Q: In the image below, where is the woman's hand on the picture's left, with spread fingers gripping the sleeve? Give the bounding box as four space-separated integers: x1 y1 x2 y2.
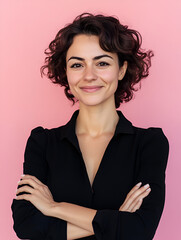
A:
16 175 56 216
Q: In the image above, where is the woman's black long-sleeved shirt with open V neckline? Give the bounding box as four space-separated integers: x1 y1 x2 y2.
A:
12 110 169 240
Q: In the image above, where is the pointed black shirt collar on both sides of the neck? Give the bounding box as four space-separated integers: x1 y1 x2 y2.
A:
60 110 134 140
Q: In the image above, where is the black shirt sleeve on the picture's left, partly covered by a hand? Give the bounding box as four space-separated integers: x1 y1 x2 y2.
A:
11 127 67 240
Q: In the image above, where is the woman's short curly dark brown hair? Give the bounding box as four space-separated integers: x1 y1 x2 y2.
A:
41 13 154 108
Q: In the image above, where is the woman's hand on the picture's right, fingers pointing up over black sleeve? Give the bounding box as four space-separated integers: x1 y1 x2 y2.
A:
119 182 151 213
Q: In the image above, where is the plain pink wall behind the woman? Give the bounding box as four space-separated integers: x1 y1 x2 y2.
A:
0 0 181 240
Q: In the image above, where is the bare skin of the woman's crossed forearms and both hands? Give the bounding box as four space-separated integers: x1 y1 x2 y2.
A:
16 175 151 240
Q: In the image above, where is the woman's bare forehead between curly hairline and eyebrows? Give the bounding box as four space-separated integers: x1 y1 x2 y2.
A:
66 34 117 59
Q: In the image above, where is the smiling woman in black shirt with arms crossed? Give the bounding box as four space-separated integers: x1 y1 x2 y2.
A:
12 13 169 240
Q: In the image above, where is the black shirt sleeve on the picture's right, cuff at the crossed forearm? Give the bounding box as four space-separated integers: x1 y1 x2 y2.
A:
92 128 169 240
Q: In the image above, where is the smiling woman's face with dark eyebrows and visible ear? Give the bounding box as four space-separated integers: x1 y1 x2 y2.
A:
66 34 127 106
